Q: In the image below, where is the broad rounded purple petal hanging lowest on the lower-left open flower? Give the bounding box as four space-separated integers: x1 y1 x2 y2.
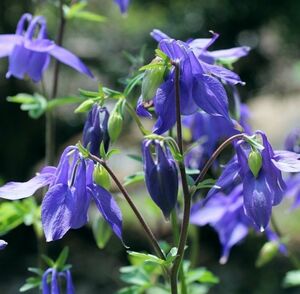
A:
42 184 74 242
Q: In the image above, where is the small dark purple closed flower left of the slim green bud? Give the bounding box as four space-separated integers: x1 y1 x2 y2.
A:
83 104 109 157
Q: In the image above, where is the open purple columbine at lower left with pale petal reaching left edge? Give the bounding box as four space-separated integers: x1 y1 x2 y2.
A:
0 146 122 241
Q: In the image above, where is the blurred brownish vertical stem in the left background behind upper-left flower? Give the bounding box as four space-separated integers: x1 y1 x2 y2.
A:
45 0 66 165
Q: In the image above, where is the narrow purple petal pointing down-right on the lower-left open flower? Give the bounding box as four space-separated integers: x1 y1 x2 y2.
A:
90 185 122 240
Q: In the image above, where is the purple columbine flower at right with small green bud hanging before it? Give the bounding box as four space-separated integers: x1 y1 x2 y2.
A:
207 131 300 231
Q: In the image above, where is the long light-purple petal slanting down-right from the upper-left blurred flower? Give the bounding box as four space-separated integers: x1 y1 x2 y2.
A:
49 45 94 78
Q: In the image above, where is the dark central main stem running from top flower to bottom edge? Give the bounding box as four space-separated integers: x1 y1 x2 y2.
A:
171 63 191 294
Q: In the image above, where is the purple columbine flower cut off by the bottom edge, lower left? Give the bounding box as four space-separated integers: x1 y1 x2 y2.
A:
42 268 75 294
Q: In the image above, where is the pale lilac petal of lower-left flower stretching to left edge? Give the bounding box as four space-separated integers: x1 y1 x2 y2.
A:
0 167 54 200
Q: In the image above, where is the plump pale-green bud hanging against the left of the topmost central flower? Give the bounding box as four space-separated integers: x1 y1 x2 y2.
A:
142 59 166 102
